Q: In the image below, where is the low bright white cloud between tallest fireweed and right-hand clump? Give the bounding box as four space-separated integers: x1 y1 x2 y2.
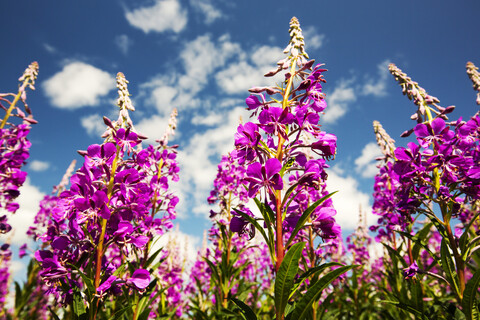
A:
327 168 376 230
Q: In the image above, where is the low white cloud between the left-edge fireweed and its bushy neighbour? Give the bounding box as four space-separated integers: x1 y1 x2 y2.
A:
1 178 44 245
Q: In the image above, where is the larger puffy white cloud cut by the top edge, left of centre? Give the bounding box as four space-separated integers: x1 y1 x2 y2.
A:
125 0 188 33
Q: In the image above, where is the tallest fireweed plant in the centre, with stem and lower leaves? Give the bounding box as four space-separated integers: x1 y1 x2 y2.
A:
223 17 352 320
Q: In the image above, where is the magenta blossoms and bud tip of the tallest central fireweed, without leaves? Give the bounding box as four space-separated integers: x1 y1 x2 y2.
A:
232 18 339 269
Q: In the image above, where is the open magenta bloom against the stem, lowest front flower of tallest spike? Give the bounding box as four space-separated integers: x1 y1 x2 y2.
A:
246 158 283 198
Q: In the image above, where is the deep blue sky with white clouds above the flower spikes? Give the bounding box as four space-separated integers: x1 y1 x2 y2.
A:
0 0 480 262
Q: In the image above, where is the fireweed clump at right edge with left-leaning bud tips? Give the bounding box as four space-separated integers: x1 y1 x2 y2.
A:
371 62 480 319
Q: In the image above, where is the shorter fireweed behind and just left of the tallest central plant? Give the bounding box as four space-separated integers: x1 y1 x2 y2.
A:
187 155 274 319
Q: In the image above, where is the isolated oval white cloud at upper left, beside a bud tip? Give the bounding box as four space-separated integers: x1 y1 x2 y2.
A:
43 61 115 109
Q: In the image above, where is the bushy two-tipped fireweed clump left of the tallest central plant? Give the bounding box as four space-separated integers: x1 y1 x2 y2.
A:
31 73 179 319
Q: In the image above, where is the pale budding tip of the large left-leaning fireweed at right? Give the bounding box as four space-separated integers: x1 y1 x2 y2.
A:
388 63 455 131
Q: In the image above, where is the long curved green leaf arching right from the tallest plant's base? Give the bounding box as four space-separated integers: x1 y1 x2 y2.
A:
291 266 356 320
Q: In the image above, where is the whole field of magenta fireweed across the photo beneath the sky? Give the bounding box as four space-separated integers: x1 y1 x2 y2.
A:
0 18 480 320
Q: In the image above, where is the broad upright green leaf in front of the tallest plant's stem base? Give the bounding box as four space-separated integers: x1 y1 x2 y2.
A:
275 242 305 314
